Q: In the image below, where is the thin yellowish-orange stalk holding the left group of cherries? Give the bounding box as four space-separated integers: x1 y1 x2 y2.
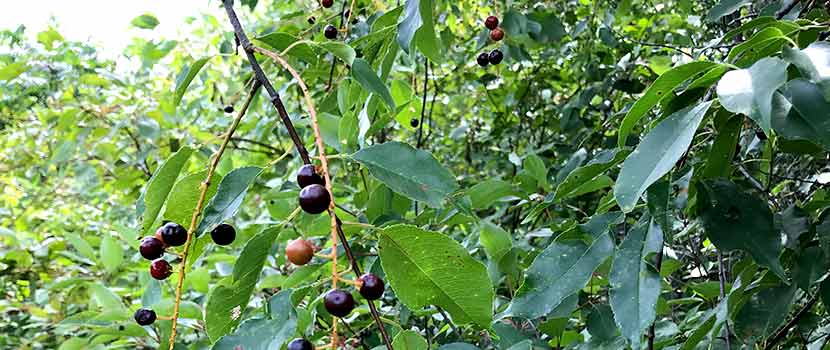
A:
169 81 262 350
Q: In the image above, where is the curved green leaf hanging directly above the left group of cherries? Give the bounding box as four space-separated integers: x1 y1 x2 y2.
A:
138 147 193 235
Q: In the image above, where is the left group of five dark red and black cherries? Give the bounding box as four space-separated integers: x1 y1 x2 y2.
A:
133 222 236 326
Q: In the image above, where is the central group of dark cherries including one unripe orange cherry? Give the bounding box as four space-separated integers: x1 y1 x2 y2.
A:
285 164 385 350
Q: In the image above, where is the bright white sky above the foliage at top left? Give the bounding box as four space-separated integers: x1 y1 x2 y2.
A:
0 0 221 58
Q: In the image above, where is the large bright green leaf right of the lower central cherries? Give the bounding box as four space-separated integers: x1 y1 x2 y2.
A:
378 225 494 328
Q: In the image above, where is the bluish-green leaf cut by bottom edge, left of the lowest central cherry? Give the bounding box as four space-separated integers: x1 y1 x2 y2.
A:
211 318 297 350
